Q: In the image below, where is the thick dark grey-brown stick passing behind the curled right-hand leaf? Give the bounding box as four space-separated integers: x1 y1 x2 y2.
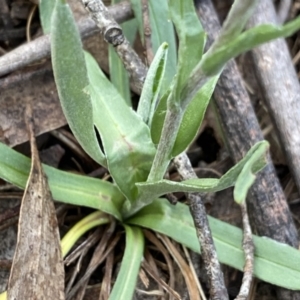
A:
196 0 299 300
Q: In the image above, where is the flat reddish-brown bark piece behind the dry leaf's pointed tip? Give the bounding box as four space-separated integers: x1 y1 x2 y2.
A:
0 64 66 146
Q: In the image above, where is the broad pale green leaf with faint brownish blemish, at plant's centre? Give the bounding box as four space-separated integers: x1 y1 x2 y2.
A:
85 54 155 201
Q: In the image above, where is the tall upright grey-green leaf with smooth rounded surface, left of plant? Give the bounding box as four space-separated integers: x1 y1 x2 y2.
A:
51 0 106 166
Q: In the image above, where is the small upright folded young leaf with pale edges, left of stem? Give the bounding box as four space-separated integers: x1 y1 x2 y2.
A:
137 43 168 126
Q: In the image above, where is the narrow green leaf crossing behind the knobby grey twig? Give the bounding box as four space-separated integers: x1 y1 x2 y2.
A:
108 0 137 106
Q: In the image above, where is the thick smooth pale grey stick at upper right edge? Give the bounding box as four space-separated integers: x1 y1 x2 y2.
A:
248 0 300 197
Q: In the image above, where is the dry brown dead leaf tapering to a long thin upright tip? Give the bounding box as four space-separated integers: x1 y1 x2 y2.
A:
7 105 65 300
